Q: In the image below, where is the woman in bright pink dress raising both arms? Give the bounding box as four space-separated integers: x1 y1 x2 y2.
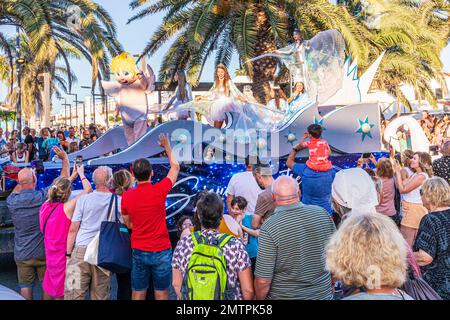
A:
39 166 92 300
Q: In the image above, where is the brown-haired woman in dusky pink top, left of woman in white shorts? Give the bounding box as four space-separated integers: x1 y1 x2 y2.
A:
376 158 400 226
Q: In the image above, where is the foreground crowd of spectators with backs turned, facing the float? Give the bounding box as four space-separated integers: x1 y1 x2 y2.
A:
2 121 450 300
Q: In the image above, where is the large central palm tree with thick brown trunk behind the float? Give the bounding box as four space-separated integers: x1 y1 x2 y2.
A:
128 0 369 102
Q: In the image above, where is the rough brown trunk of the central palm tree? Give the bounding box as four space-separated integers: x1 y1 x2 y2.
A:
252 10 277 104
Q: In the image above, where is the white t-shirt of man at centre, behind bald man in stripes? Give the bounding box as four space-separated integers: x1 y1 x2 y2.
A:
226 171 264 214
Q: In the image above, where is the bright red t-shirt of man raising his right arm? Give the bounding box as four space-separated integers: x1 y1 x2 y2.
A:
121 178 172 252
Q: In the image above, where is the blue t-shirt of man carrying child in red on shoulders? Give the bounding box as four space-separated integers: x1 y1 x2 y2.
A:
292 163 336 215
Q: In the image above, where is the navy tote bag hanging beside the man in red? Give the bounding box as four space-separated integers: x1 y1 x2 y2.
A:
97 194 132 273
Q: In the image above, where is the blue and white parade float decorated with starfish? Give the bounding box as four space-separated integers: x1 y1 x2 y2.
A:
3 30 383 240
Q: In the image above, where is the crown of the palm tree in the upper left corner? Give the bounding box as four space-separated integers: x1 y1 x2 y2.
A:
0 0 122 119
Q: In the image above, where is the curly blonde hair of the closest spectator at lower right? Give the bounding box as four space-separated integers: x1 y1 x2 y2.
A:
326 214 407 289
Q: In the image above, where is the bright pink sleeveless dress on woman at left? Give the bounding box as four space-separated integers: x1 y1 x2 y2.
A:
39 201 70 297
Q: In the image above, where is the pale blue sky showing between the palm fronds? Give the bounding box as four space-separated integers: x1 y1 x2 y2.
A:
0 0 450 110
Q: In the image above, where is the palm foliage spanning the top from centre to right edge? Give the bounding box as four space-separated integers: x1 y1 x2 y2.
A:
129 0 450 105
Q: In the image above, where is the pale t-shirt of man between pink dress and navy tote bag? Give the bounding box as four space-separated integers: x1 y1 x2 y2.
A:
72 191 121 247
